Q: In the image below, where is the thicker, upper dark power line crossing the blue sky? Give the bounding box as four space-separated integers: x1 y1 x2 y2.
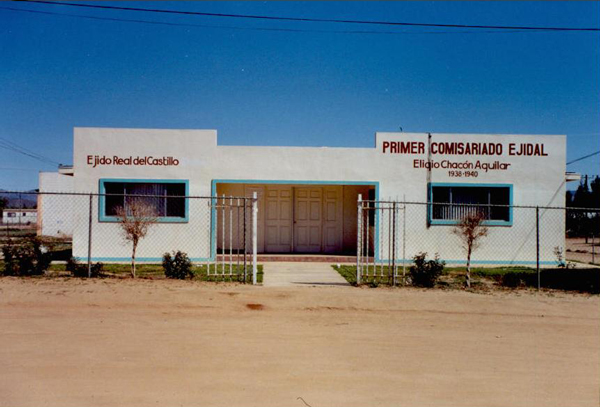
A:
12 0 600 31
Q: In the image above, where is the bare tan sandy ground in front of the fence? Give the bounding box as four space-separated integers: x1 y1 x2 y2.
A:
0 278 600 407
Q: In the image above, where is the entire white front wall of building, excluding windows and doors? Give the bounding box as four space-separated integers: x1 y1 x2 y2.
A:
67 128 566 262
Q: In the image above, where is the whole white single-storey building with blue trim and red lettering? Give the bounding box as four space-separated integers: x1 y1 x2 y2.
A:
40 128 566 264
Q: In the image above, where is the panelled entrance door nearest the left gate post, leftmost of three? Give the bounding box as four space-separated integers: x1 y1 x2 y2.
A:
265 186 293 253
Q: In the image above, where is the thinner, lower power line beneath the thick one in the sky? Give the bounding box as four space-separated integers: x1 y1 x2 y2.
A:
0 6 542 35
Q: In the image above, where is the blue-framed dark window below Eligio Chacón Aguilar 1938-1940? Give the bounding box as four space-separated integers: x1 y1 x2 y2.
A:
429 184 512 225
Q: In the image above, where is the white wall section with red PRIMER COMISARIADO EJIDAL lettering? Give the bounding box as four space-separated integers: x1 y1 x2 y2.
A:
376 133 566 264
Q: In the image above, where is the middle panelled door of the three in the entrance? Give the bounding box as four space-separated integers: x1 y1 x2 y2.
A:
294 187 323 253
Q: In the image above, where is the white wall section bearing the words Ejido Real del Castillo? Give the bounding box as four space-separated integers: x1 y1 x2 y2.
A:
73 128 217 261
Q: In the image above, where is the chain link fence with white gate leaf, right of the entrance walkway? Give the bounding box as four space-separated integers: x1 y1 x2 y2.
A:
356 198 600 286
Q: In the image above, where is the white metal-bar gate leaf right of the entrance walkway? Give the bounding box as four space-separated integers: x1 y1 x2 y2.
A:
356 195 406 285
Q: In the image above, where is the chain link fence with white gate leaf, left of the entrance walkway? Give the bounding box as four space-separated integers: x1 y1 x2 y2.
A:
0 192 258 283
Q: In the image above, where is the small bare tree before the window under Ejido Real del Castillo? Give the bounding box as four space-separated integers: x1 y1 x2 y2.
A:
117 199 157 278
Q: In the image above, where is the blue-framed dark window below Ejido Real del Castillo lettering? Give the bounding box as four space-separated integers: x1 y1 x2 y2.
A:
98 178 189 223
